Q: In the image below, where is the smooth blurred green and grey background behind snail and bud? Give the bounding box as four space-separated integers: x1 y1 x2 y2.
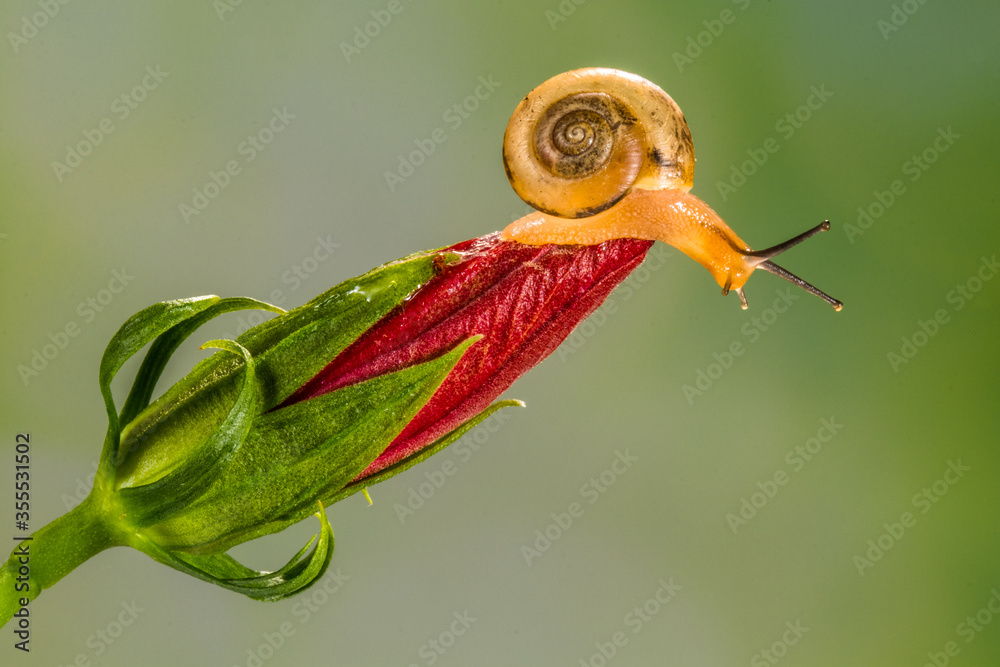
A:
0 0 1000 667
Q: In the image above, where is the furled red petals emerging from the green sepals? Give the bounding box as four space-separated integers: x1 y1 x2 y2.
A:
285 233 652 479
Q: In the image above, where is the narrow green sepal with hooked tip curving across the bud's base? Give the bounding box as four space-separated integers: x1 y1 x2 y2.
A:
118 342 257 528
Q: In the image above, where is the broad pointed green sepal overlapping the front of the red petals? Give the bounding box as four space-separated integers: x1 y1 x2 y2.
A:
144 336 480 553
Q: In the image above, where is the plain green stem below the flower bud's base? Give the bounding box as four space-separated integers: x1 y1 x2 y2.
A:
0 496 122 626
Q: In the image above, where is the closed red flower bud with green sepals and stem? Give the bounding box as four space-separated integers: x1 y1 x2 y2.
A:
0 234 650 618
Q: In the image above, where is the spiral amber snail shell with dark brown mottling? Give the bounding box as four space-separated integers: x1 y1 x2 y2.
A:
503 68 694 218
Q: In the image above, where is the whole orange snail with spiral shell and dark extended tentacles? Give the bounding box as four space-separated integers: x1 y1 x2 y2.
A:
501 68 843 310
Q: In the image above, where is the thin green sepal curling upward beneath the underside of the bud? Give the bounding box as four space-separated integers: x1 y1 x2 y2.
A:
132 504 334 602
